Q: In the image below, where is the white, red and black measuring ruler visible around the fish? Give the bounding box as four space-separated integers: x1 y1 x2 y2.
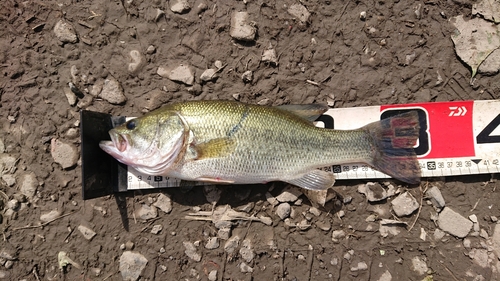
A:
81 100 500 199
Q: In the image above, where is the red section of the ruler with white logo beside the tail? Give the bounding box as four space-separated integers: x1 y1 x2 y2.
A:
380 101 475 159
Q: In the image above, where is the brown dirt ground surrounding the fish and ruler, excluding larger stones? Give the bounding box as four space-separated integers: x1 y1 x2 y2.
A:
0 0 500 280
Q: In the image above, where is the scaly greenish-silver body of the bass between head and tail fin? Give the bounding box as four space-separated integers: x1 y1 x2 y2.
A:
168 102 370 183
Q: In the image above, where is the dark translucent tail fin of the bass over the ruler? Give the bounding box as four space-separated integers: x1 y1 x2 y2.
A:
363 111 421 184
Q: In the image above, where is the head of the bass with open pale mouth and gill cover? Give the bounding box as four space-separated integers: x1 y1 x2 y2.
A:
99 111 189 175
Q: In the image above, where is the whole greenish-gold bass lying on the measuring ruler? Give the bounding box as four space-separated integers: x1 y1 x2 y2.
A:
99 101 421 190
